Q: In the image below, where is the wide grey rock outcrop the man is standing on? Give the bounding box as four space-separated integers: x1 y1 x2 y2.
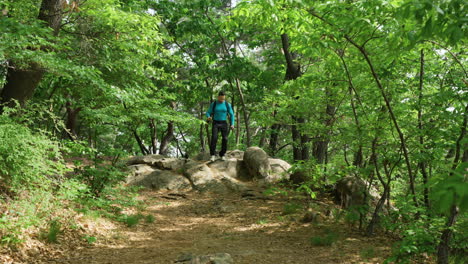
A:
127 147 291 193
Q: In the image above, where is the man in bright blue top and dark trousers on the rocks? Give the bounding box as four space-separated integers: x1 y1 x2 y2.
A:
206 92 234 161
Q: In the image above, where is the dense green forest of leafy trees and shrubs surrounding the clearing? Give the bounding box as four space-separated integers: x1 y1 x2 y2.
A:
0 0 468 263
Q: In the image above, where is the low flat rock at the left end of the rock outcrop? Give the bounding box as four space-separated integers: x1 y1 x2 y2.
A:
127 169 192 190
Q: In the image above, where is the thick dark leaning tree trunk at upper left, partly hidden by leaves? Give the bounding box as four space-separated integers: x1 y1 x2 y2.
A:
0 0 63 113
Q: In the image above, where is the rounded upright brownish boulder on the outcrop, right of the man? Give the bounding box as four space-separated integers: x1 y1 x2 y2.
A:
244 147 271 179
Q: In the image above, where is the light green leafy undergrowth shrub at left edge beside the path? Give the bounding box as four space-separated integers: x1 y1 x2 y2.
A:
0 113 142 247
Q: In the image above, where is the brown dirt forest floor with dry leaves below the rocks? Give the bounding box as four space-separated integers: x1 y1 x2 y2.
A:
1 185 404 264
